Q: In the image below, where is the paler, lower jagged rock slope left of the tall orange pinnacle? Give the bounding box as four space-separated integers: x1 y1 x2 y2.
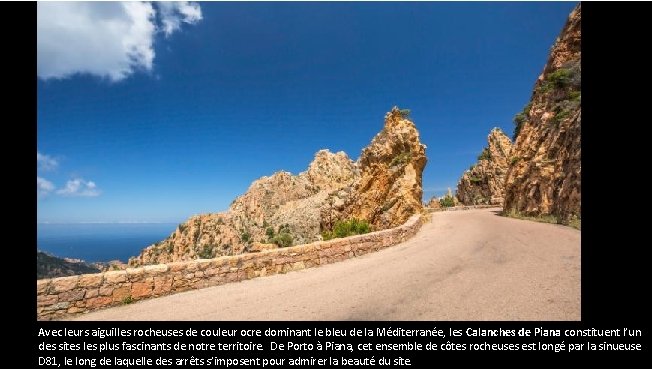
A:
129 150 355 266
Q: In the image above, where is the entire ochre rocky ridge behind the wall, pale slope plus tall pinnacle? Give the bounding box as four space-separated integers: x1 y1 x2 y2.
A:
129 108 426 266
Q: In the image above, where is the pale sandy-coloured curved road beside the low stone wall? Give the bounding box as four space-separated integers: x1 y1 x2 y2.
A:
72 209 580 320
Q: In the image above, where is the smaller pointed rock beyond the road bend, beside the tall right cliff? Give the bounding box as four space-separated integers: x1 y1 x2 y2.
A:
457 128 512 205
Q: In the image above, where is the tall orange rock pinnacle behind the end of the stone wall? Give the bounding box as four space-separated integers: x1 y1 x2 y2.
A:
345 107 426 229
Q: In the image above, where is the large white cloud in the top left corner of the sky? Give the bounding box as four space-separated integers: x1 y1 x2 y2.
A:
36 1 201 81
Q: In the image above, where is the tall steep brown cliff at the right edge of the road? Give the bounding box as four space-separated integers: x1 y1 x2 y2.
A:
504 5 582 223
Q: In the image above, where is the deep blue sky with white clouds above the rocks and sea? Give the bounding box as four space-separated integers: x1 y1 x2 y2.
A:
37 2 575 222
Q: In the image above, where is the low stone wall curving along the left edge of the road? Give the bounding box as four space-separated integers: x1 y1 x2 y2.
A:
36 215 422 320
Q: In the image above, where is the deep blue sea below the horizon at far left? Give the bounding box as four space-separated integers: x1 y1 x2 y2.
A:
36 223 177 263
